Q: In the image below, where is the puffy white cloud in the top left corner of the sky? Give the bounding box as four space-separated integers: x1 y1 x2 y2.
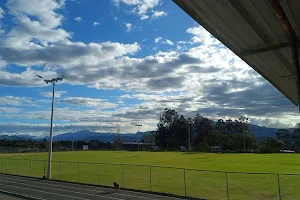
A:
0 0 71 49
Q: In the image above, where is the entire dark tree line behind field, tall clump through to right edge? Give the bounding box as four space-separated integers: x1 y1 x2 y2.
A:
152 109 300 153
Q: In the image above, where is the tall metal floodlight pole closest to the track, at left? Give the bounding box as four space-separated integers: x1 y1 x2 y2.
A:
37 75 67 179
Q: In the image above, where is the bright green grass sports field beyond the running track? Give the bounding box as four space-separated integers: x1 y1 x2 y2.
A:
0 151 300 200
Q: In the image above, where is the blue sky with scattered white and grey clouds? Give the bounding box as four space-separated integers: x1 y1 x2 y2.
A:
0 0 300 136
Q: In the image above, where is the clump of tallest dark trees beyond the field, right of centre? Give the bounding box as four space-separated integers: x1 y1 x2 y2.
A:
153 109 257 152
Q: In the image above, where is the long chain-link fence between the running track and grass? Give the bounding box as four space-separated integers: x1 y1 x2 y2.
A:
0 158 300 200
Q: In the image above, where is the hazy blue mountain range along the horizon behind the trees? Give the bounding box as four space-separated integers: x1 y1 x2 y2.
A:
0 124 293 142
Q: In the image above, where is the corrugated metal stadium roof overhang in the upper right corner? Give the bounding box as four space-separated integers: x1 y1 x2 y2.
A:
173 0 300 105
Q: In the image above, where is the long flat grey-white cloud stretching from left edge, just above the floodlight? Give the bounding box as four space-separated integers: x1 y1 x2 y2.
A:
0 42 140 67
